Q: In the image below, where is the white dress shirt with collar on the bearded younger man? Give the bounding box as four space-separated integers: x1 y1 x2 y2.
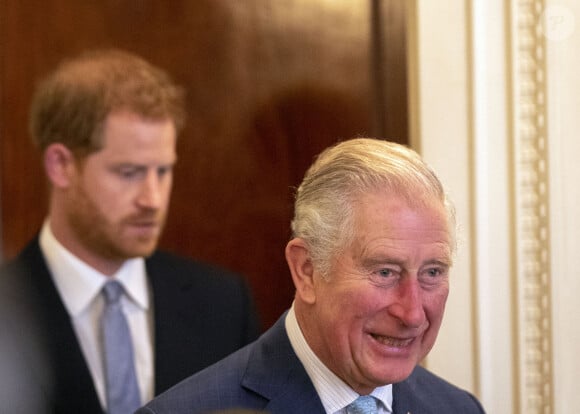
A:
40 220 155 409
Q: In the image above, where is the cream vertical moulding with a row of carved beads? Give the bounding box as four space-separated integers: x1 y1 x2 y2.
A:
512 0 554 414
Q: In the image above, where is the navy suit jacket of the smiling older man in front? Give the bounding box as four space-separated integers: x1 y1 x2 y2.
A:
136 315 484 414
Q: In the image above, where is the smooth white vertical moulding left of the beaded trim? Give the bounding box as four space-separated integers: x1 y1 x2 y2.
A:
468 0 518 414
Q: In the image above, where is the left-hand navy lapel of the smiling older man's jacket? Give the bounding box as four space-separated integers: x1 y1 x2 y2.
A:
237 313 325 414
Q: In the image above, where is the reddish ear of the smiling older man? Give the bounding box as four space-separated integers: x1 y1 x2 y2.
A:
285 238 316 304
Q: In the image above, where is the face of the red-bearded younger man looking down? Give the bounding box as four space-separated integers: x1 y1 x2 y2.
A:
68 111 176 268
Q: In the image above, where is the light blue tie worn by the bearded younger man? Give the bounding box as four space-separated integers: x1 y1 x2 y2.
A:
101 281 141 414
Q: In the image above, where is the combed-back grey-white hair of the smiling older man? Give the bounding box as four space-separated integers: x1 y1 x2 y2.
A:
291 138 456 277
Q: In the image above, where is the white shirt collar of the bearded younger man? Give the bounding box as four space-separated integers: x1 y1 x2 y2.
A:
39 220 149 317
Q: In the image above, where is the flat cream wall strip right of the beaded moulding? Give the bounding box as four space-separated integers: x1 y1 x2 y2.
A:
547 0 580 414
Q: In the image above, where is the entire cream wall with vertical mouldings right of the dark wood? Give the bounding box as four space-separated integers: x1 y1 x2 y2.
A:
408 0 580 414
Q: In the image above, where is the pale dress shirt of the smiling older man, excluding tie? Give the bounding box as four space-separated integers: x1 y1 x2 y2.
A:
285 304 393 414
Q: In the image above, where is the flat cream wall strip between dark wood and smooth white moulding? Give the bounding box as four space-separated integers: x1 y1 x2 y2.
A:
409 1 476 396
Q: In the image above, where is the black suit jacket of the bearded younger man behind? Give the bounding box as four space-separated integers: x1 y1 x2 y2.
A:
0 239 259 414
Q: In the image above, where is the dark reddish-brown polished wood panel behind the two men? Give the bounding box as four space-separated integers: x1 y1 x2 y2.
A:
0 0 407 327
